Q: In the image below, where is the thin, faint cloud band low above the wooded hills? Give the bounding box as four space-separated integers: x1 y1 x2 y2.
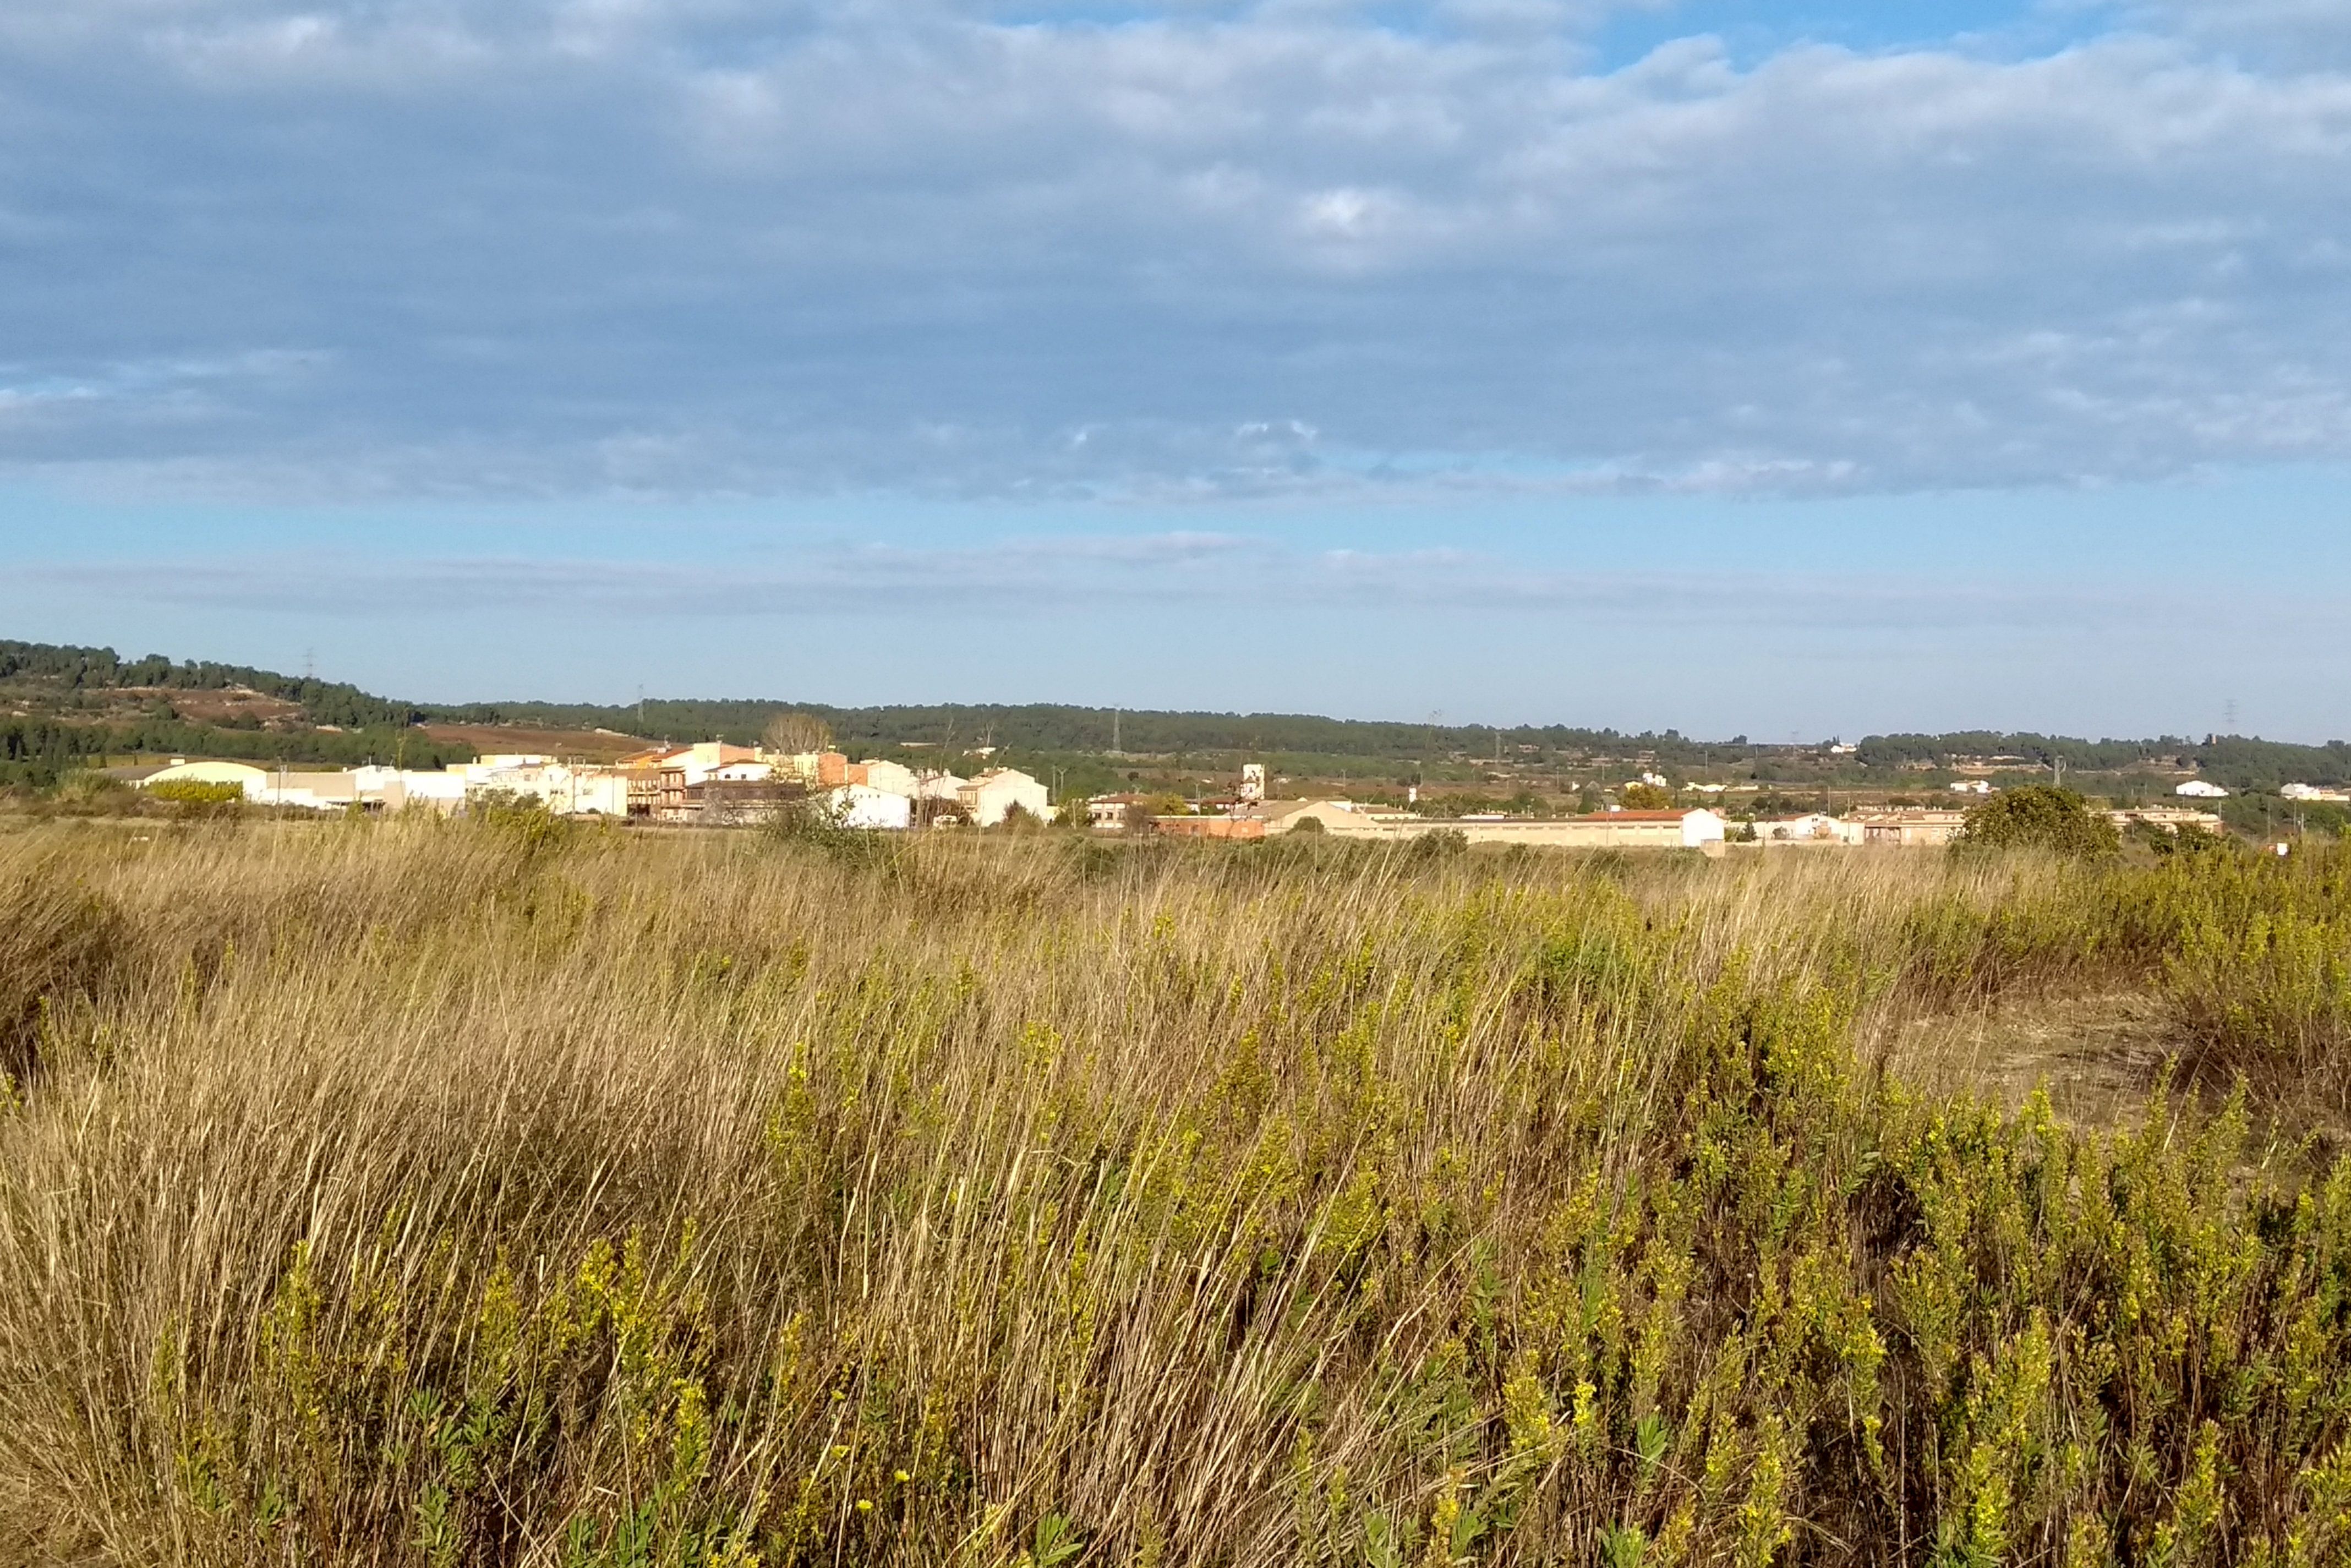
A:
19 531 2346 637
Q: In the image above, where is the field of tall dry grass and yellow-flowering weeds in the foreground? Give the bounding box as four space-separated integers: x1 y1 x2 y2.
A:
0 816 2351 1568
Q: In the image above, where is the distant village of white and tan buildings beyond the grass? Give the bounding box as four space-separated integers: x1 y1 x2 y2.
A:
127 740 2248 856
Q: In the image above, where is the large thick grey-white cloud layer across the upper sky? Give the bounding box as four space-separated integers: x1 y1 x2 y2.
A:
0 0 2351 501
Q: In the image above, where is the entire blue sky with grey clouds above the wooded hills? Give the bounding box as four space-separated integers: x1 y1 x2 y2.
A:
0 0 2351 740
